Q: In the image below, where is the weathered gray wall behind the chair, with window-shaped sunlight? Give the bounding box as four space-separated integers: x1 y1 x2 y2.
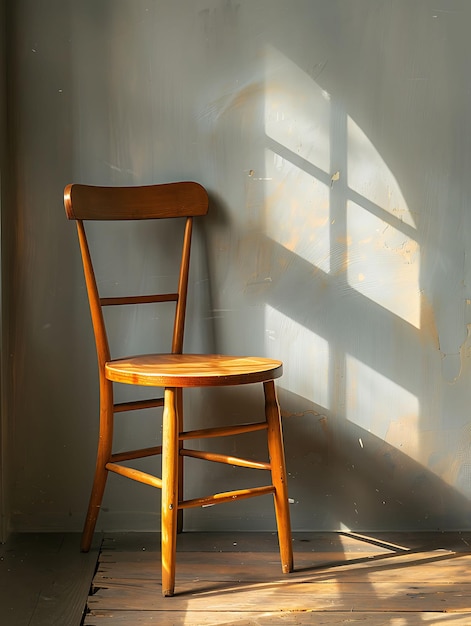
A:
5 0 471 530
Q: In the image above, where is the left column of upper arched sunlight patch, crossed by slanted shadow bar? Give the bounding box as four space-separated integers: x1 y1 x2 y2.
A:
265 48 330 272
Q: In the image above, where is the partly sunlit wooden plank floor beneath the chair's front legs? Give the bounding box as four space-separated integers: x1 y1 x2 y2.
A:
84 533 471 626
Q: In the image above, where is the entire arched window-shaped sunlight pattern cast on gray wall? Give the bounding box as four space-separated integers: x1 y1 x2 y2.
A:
264 47 420 450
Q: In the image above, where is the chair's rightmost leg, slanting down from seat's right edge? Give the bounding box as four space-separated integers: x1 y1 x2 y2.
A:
263 380 293 574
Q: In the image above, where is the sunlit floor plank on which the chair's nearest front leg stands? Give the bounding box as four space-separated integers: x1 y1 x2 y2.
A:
88 580 471 613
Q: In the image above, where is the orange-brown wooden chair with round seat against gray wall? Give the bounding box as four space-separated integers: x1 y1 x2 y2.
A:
64 182 293 596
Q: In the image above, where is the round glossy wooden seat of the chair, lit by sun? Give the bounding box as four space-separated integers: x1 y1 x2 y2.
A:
105 354 283 387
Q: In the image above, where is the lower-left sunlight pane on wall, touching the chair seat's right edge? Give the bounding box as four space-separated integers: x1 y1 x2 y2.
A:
265 305 329 408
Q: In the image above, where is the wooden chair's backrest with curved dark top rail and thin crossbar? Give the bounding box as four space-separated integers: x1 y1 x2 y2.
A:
64 182 208 372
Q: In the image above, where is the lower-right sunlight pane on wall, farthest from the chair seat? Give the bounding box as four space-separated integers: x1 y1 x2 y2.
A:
345 354 420 450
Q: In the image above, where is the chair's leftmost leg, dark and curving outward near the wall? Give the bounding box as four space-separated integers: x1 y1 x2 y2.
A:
80 380 114 552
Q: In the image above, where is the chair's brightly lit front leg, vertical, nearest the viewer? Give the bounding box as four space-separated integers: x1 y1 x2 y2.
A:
161 388 180 596
